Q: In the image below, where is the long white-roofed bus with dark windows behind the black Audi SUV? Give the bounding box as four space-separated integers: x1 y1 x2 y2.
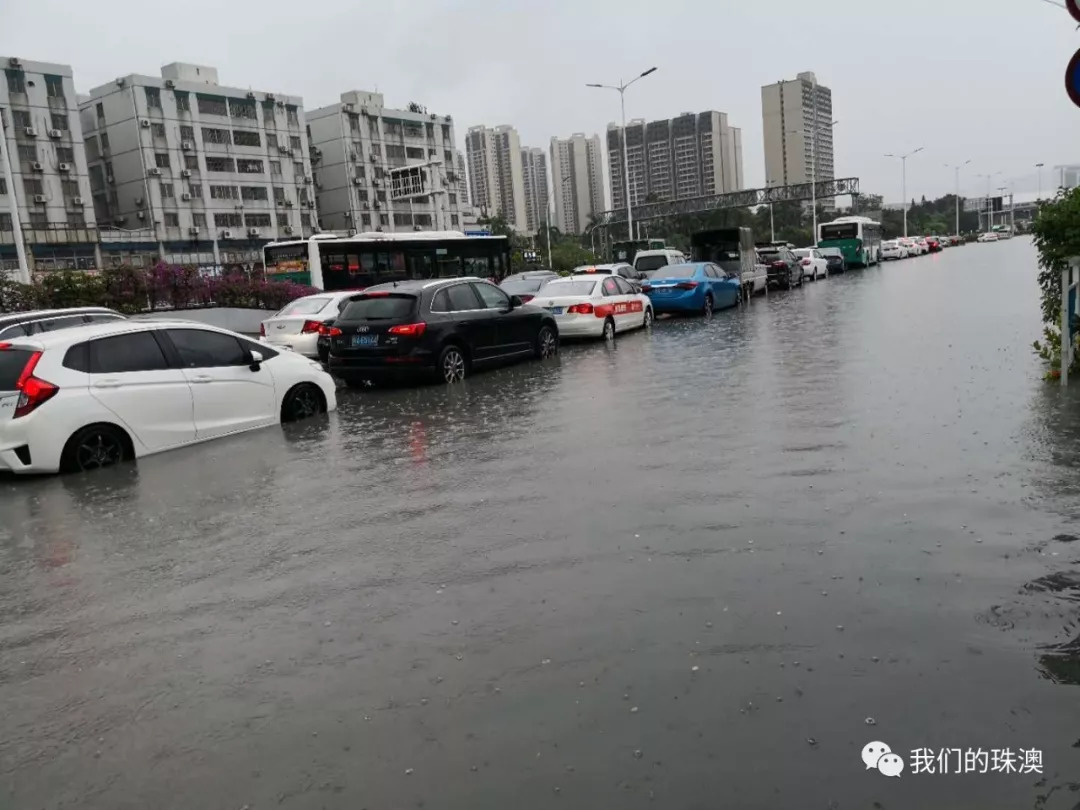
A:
262 231 510 291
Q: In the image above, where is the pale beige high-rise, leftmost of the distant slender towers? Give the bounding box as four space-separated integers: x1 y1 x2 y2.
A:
465 125 529 233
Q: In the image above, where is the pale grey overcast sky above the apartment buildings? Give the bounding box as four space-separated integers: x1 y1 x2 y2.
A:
0 0 1080 206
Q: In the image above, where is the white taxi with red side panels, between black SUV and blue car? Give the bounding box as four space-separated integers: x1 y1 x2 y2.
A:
529 274 652 340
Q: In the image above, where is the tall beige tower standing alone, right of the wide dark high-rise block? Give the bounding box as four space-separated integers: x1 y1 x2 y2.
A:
761 71 836 211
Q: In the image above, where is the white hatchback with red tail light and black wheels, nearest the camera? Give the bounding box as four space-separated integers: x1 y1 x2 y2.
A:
0 321 337 473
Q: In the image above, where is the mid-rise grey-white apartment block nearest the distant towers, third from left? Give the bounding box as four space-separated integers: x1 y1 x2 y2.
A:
308 90 464 232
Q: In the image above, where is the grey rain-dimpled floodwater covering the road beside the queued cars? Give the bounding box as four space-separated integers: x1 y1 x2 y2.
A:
0 239 1080 810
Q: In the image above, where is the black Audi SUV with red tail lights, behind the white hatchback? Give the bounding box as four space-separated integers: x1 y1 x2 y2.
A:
328 279 558 387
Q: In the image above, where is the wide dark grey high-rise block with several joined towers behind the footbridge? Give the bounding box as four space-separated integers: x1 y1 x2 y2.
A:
607 110 743 208
